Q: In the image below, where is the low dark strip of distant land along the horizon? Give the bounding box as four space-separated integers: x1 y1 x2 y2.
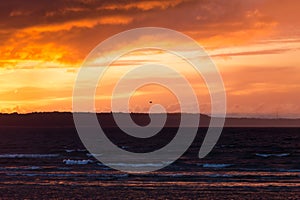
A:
0 112 300 127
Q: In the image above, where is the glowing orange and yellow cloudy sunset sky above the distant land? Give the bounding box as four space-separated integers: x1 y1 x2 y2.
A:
0 0 300 118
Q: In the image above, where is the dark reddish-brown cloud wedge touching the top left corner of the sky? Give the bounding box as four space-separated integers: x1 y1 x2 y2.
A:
0 0 188 29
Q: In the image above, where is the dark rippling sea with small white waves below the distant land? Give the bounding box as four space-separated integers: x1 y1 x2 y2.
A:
0 127 300 199
